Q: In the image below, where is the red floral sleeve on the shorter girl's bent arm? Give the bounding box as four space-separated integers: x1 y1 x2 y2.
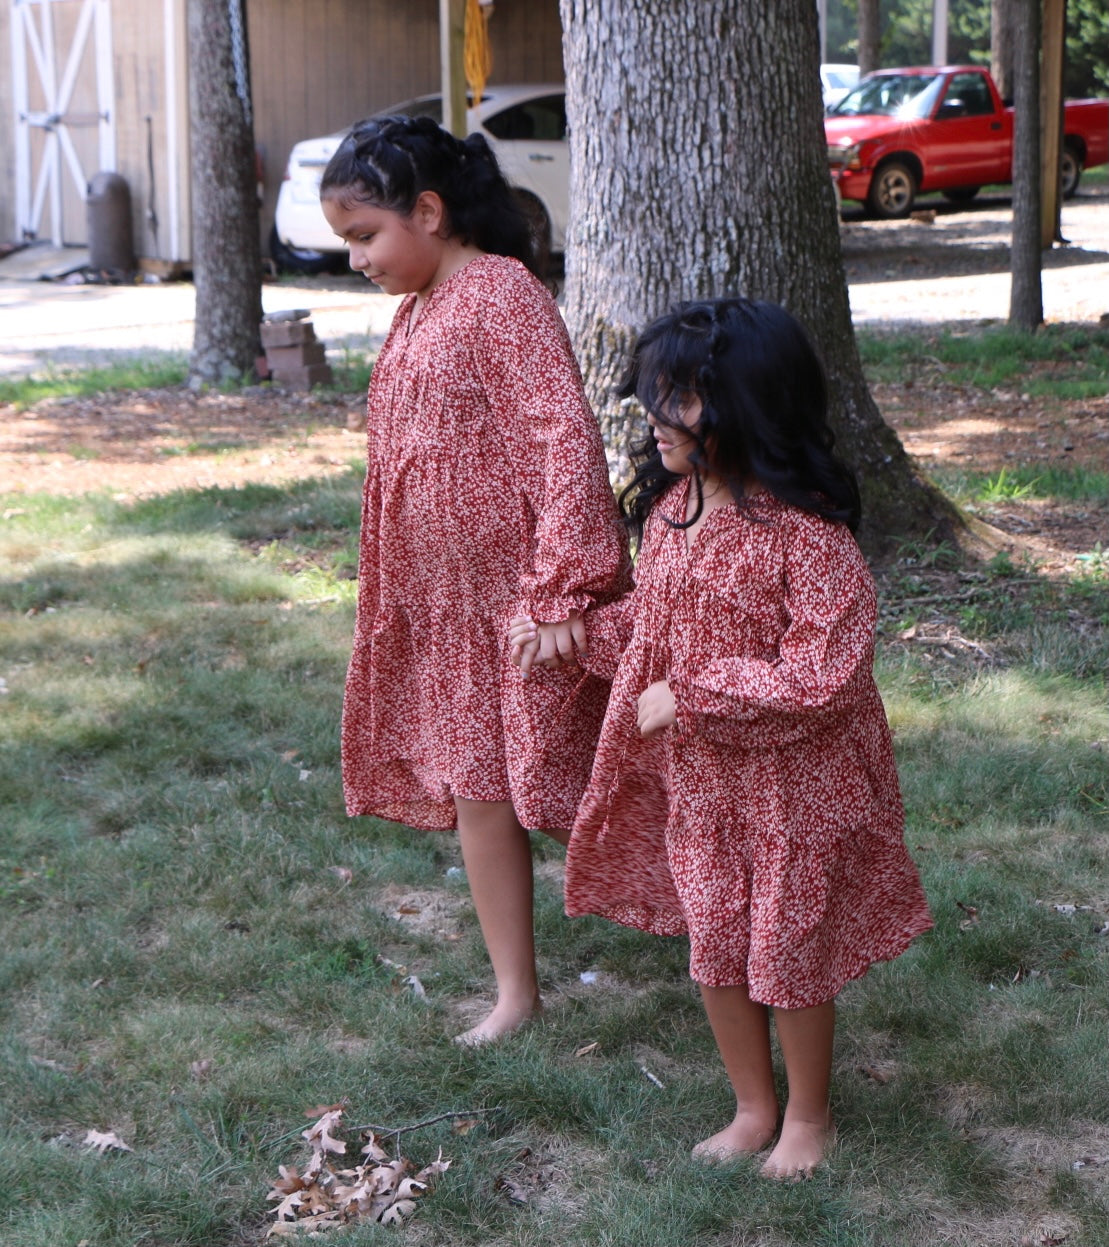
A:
670 521 877 748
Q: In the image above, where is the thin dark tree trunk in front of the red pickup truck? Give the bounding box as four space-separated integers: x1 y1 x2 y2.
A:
1009 0 1044 333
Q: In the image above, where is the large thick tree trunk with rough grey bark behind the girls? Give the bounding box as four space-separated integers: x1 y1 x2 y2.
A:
561 0 958 550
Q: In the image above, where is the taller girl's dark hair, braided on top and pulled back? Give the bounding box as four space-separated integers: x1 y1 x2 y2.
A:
319 116 539 273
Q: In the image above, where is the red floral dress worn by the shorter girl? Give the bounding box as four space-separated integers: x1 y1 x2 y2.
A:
566 481 932 1009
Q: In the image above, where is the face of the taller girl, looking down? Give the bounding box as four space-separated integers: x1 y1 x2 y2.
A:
321 193 445 296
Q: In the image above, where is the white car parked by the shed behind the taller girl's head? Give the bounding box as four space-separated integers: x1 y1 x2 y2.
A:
269 82 561 273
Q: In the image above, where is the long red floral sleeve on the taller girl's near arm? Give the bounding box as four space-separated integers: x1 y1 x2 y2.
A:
475 271 629 622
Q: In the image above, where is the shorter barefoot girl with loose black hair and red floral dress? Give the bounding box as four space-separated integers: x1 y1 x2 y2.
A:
509 298 932 1178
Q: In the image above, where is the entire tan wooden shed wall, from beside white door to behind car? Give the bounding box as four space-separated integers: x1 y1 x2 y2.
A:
0 0 564 263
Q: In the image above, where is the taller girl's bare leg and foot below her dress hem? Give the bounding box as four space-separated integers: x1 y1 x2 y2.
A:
454 797 565 1045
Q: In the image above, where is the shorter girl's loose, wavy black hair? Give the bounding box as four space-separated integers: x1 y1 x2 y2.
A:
619 298 861 536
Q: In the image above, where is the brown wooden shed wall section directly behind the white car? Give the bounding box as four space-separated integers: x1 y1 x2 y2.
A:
247 0 564 234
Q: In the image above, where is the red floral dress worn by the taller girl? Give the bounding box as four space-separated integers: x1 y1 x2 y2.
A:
342 256 629 829
